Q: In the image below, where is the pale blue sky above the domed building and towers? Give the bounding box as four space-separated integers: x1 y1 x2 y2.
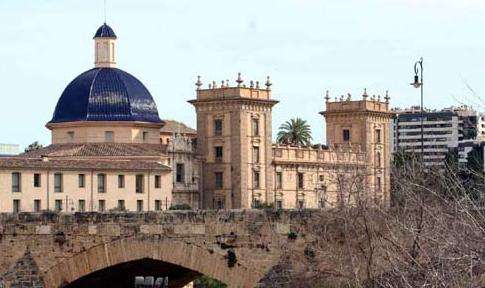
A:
0 0 485 147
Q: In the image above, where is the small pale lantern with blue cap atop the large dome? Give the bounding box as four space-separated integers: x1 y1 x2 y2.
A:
94 23 117 68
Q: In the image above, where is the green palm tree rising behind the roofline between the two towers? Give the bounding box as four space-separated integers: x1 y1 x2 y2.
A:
276 118 312 146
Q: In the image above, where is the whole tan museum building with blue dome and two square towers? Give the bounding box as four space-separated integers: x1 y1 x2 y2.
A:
0 23 393 212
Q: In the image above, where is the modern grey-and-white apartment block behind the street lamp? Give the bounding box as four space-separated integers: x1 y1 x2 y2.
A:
392 106 485 166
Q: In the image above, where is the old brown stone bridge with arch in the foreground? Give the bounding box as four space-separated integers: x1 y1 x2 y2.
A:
0 210 322 288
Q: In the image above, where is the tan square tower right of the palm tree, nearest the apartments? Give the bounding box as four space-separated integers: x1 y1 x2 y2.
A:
321 90 393 205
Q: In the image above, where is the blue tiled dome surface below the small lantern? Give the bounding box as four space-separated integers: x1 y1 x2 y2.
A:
49 68 162 123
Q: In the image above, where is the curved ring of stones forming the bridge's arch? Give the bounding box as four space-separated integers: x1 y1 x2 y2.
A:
42 238 264 288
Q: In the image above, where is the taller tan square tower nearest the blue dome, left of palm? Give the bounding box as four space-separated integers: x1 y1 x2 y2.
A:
189 75 278 209
